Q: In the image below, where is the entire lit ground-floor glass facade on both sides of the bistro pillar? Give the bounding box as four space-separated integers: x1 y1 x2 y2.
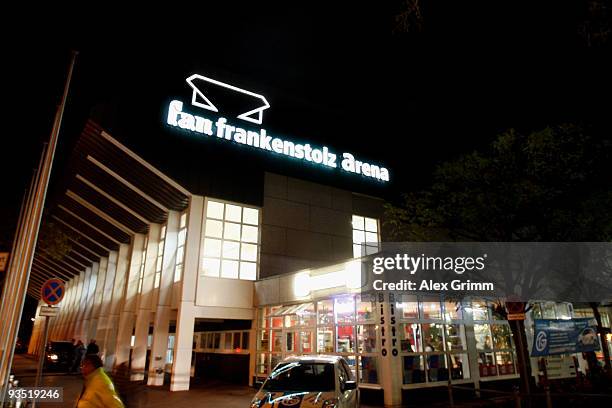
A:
256 294 517 387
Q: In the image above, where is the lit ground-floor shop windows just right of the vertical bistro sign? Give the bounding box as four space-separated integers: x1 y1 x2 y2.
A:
398 296 514 385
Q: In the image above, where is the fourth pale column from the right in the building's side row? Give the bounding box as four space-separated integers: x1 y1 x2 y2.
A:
115 234 145 365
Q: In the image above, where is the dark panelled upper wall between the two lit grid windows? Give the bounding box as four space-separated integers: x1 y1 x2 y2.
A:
259 173 382 278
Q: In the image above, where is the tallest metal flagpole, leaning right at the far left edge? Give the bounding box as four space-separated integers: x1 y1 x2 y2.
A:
0 51 77 401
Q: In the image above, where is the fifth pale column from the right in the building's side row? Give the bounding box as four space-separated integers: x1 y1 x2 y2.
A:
101 244 131 371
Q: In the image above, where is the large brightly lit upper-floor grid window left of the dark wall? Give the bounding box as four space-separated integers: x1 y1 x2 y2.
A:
202 199 260 280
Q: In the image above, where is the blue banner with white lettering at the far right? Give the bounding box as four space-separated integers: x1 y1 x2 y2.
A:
531 318 599 357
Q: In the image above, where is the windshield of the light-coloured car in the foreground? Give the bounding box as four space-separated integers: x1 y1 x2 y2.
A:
263 362 336 391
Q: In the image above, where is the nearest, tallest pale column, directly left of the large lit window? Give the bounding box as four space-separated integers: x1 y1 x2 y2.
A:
170 196 204 391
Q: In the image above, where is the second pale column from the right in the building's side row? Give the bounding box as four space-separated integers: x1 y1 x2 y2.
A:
147 211 180 385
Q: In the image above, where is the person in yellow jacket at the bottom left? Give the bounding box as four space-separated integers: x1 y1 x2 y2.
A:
76 354 125 408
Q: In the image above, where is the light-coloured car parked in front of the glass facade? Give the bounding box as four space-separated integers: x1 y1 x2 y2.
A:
251 355 359 408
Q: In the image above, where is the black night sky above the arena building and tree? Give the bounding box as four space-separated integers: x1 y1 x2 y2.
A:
0 0 612 247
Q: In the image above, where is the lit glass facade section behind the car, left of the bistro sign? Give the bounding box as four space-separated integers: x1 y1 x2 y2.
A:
255 295 380 384
